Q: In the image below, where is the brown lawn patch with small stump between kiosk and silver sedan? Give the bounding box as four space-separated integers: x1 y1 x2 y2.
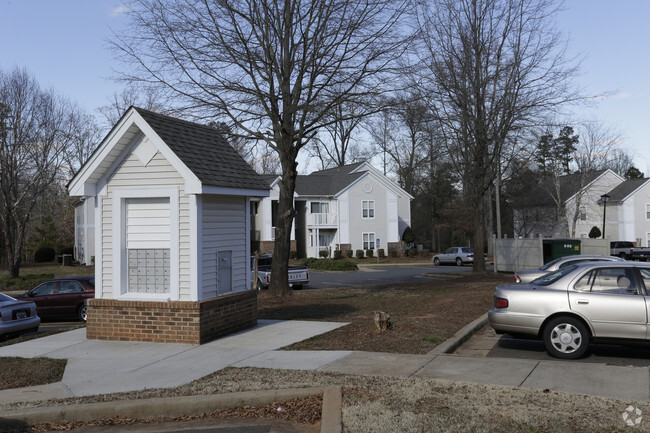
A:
258 273 512 353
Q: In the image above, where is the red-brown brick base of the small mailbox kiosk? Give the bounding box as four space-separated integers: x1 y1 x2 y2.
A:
86 290 257 344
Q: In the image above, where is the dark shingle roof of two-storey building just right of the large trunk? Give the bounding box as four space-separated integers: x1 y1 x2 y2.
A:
296 162 365 197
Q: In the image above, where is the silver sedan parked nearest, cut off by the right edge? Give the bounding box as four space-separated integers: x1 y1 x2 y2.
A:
488 261 650 359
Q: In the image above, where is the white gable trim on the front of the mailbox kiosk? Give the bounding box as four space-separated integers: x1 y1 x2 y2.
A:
68 108 201 196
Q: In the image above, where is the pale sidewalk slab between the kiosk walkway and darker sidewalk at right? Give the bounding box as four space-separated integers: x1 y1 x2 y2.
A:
233 350 353 370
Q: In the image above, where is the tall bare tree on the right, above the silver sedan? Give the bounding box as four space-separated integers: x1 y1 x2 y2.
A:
419 0 577 271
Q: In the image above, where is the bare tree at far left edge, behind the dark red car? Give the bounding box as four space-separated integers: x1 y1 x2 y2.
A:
0 69 66 277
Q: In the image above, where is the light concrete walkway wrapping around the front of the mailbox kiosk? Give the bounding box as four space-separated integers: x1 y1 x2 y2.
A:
0 320 346 401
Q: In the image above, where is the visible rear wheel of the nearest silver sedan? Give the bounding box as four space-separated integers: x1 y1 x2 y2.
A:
544 317 589 359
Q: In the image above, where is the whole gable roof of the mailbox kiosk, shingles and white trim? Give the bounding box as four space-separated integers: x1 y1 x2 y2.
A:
68 107 269 196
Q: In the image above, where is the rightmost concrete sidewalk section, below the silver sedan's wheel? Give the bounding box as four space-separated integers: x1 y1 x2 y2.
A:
522 361 650 401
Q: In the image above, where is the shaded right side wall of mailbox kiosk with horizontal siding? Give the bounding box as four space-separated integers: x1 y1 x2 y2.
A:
198 196 248 299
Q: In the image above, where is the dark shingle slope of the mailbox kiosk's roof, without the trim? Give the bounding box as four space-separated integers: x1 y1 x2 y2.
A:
134 107 269 190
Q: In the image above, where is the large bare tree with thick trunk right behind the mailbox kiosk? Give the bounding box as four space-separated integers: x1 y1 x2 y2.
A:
113 0 407 296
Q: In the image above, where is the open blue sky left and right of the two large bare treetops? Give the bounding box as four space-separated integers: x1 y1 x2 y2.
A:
0 0 650 175
